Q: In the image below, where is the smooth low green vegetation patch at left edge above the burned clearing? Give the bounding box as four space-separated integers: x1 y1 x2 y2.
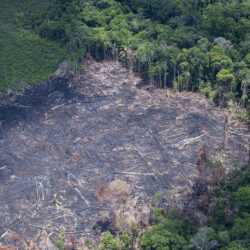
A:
0 27 68 92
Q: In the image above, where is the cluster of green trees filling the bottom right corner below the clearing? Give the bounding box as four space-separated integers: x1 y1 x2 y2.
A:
141 168 250 250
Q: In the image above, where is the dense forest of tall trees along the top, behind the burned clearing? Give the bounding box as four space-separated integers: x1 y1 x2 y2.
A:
0 0 250 117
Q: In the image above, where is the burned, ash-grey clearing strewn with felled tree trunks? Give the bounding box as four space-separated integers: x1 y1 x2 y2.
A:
0 62 249 249
